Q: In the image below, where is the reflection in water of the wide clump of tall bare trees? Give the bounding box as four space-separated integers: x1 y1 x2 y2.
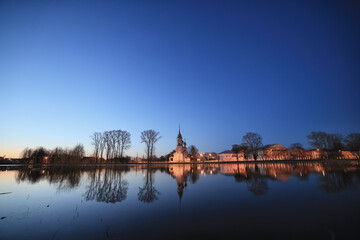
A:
84 168 129 203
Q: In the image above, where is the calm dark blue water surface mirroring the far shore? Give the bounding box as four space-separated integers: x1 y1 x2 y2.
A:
0 161 360 239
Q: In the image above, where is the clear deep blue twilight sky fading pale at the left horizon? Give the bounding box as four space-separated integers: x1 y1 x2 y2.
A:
0 0 360 157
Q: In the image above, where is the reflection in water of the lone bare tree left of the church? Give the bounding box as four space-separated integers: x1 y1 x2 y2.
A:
138 167 160 203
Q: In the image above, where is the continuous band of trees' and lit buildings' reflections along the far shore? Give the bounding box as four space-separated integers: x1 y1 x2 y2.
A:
3 161 360 199
